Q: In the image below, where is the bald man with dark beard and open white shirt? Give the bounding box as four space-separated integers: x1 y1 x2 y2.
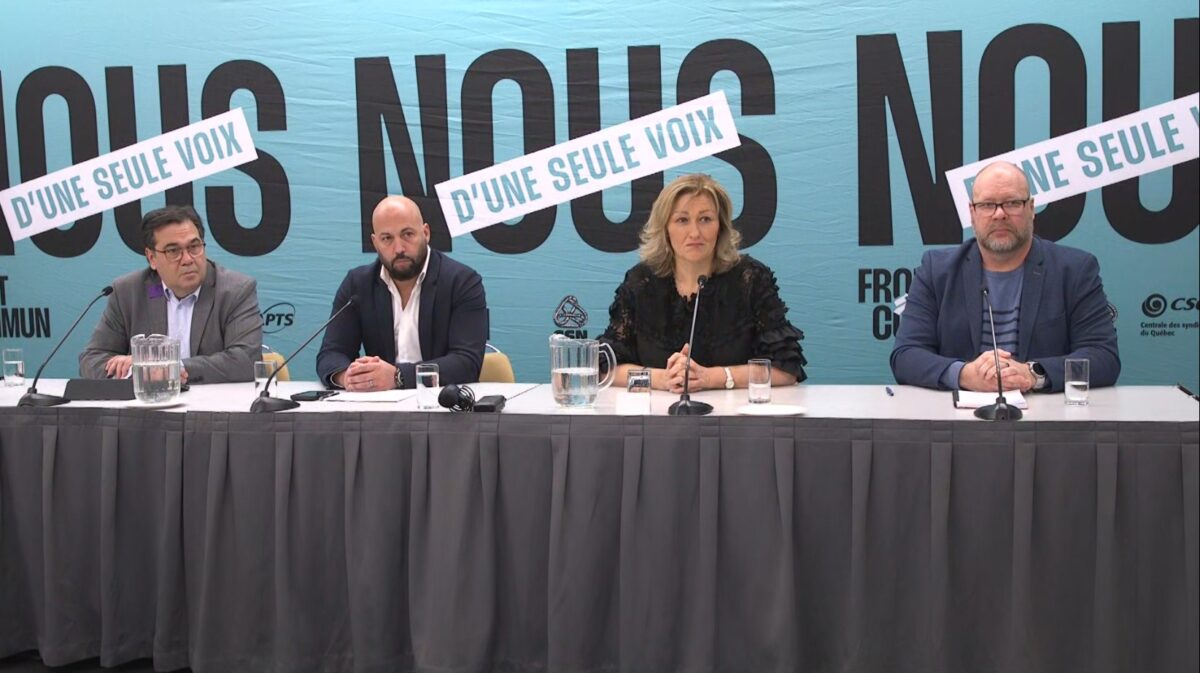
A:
317 197 488 391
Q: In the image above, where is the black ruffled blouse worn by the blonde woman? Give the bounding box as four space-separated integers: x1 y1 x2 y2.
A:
600 254 808 381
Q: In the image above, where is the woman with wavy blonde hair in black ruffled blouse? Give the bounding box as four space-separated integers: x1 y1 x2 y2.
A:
600 174 808 392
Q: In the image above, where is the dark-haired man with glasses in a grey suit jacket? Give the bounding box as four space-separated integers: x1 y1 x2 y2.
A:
79 205 263 384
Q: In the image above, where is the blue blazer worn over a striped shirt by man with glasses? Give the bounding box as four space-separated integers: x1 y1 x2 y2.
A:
892 236 1121 392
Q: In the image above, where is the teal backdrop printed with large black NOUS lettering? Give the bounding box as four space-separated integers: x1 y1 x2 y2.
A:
0 0 1200 387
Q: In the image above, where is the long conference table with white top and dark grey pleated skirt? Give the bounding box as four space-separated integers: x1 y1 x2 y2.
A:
0 380 1200 673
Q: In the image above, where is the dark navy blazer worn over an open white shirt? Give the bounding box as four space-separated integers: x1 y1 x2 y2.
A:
317 248 488 387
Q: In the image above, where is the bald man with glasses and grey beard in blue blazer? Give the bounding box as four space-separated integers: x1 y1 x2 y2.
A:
892 162 1121 392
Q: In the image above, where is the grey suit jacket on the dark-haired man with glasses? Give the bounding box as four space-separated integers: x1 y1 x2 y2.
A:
79 260 263 383
